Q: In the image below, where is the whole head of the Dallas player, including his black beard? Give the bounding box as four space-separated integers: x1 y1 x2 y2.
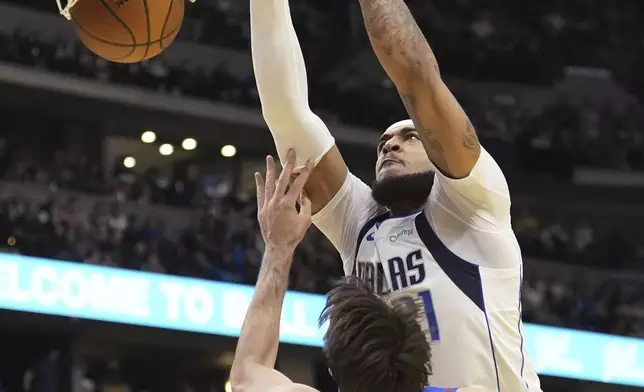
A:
371 120 434 207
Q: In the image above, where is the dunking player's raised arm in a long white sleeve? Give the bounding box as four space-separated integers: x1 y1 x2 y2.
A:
250 0 348 213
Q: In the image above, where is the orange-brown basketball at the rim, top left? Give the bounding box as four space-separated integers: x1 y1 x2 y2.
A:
70 0 185 63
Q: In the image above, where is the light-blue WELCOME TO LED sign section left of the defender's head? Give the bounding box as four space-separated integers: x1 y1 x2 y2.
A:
0 253 324 346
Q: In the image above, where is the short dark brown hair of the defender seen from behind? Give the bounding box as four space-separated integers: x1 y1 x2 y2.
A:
320 276 431 392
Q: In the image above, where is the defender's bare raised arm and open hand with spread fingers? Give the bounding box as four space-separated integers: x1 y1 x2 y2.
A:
230 150 313 392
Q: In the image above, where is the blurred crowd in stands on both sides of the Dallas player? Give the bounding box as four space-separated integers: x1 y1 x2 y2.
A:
0 145 644 335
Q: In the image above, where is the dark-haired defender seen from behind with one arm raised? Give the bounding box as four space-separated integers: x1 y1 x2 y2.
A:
230 150 485 392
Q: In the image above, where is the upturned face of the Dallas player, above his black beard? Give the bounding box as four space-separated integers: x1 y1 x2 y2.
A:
376 128 433 181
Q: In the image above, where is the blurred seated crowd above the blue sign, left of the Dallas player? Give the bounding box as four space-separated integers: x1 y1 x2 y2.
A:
0 144 342 292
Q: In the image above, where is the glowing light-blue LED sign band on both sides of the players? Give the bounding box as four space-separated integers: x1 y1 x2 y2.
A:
0 253 644 386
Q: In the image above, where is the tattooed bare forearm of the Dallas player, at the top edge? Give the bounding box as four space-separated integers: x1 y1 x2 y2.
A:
360 0 439 85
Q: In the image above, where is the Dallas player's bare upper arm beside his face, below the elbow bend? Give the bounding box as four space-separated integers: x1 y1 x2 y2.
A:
399 79 481 178
